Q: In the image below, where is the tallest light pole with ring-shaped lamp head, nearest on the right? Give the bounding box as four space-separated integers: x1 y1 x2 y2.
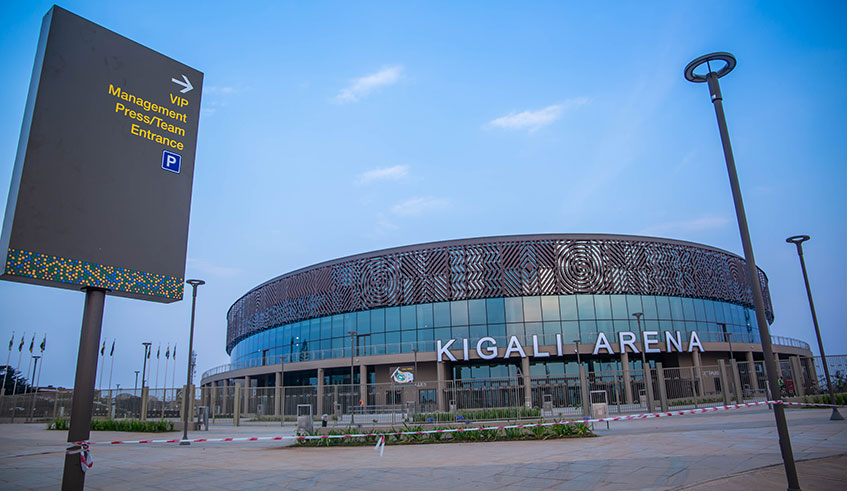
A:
684 52 800 490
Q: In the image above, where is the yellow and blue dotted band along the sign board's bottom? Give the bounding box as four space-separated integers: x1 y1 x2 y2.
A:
6 249 183 300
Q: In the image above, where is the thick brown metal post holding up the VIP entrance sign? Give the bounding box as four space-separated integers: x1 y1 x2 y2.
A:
62 287 106 491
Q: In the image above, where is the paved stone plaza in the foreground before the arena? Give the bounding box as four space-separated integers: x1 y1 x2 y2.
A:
0 408 847 490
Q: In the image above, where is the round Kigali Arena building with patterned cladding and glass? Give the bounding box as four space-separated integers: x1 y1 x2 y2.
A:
201 234 814 414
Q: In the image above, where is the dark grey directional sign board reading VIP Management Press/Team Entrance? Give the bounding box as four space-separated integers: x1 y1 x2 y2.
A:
0 6 203 302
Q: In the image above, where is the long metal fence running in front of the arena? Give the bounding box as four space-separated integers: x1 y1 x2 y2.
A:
0 356 847 424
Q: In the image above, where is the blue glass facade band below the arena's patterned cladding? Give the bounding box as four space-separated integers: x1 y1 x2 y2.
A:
231 295 760 370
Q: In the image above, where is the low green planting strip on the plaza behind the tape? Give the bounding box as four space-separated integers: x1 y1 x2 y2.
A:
297 423 595 447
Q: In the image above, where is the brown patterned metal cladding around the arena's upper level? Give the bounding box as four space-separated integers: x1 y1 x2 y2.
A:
227 234 773 353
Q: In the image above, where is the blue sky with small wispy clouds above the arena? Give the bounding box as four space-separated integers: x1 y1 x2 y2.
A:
0 1 847 387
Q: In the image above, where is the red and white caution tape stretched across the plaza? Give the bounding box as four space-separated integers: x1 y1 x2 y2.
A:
73 400 842 450
